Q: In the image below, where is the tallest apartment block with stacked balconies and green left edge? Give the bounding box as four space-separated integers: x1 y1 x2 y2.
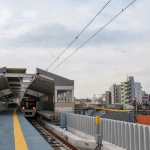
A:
121 77 135 104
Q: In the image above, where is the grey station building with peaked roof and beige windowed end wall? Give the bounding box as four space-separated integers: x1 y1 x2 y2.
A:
0 67 74 115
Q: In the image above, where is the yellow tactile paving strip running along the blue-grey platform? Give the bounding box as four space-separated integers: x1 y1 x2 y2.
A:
13 109 28 150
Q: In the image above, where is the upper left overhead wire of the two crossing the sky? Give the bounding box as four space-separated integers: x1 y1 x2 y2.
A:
46 0 111 71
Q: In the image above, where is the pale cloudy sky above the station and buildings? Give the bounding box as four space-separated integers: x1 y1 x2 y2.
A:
0 0 150 98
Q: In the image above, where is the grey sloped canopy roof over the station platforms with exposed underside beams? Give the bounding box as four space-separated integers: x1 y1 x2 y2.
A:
0 67 74 100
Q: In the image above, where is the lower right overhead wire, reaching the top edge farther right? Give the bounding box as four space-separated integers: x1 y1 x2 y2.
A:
51 0 136 72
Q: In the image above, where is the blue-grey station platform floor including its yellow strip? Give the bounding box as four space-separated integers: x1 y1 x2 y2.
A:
0 109 53 150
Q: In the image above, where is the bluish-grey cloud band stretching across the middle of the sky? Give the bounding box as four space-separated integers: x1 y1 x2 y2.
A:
0 23 149 49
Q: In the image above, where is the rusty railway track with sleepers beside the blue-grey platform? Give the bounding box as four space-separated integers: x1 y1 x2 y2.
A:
29 119 79 150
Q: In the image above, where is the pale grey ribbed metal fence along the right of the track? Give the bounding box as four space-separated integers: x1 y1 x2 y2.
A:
63 113 150 150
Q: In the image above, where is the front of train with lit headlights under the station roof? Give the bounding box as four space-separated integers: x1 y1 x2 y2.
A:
20 98 36 117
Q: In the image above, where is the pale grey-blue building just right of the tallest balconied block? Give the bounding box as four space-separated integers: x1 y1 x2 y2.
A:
134 82 142 103
